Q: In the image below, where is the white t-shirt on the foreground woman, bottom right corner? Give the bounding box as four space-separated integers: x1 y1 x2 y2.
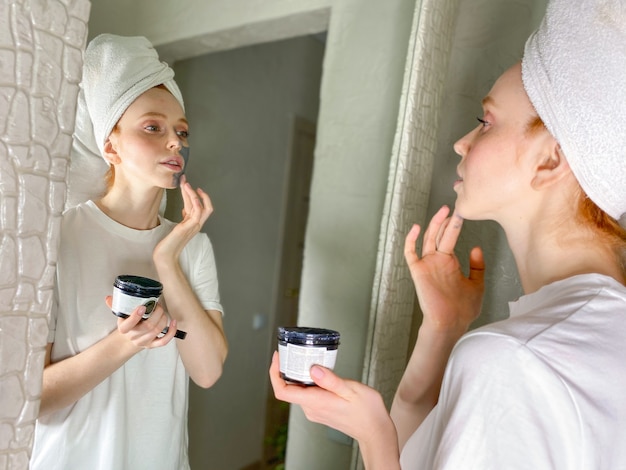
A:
401 274 626 470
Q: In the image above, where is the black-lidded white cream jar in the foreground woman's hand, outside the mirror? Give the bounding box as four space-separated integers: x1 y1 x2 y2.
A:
278 326 340 385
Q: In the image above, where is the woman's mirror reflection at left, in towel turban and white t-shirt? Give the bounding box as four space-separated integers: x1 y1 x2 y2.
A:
31 34 227 470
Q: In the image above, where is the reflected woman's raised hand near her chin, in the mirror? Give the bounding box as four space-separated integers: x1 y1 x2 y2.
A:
153 175 213 263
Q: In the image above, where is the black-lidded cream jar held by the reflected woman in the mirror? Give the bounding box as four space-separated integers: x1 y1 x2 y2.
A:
111 274 187 339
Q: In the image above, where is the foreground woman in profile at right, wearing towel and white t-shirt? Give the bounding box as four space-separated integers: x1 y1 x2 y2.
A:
270 0 626 470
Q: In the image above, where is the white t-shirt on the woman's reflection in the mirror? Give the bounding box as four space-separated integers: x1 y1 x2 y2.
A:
31 201 223 470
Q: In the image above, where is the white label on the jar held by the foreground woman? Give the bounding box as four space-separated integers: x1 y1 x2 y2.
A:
278 344 337 384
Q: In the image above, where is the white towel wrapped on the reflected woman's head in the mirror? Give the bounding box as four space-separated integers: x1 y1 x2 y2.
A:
66 34 185 207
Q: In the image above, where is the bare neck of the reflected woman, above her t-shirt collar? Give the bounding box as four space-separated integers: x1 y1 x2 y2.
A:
94 188 164 230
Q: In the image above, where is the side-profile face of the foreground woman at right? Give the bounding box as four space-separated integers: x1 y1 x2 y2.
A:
454 64 540 223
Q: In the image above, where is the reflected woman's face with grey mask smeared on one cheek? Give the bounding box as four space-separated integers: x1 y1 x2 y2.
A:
109 88 189 188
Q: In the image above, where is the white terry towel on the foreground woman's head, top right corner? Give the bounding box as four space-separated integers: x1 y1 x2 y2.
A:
522 0 626 226
